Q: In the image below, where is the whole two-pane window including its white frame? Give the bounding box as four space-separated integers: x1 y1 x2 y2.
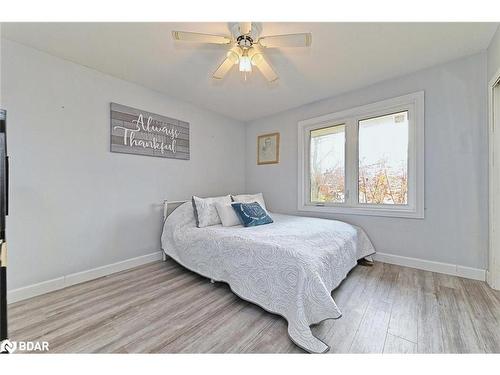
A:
298 92 424 218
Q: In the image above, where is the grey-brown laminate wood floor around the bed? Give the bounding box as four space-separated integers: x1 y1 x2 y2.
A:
9 259 500 353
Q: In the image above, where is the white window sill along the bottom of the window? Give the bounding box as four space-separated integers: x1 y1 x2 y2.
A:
298 205 424 219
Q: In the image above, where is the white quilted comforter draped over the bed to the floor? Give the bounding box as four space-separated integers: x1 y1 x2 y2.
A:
162 202 375 353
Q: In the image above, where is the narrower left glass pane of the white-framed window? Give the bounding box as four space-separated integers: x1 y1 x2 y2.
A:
310 125 345 203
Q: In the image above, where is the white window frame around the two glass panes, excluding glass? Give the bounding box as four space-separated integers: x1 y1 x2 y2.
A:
297 91 424 219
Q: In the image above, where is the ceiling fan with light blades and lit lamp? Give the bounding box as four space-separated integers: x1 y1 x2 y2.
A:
172 22 312 82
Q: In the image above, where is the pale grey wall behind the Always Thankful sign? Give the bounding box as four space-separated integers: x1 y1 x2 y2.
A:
1 40 245 289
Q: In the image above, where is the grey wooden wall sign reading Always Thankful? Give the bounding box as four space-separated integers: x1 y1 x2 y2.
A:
111 103 189 160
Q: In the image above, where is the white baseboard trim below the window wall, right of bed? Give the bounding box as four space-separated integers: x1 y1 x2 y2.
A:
374 252 486 281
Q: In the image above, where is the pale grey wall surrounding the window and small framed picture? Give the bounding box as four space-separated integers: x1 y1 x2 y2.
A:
246 53 488 269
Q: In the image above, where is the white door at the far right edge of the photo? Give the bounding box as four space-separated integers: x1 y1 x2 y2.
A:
488 82 500 289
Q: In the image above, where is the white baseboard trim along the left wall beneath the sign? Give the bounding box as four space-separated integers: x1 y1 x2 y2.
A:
7 251 162 303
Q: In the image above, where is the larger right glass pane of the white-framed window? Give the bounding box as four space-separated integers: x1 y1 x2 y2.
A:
359 111 408 204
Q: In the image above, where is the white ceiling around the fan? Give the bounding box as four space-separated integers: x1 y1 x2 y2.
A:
2 23 498 121
